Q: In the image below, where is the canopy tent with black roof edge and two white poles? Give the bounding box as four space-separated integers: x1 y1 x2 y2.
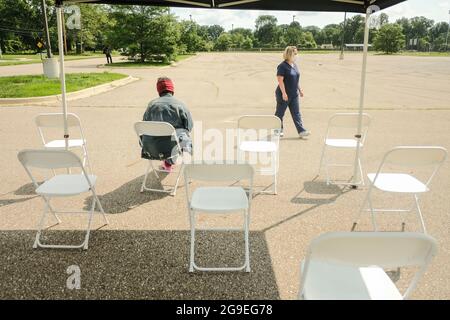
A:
56 0 405 187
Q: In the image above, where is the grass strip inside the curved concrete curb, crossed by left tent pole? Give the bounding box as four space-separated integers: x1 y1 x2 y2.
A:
0 72 127 98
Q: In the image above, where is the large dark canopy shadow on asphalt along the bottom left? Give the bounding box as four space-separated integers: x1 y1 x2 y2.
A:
0 230 280 300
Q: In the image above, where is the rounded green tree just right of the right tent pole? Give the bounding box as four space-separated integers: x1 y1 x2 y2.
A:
374 24 405 54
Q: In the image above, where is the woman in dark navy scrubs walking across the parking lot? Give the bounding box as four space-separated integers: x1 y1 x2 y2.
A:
275 46 310 138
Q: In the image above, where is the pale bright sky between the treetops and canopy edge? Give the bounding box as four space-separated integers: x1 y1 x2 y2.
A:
171 0 450 31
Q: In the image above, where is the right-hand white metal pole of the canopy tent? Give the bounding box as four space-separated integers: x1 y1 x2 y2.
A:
352 8 371 188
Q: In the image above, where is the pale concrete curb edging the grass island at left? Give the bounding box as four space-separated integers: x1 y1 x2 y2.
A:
0 76 139 106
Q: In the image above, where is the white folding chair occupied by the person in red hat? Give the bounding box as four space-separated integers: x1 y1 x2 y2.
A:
134 121 184 196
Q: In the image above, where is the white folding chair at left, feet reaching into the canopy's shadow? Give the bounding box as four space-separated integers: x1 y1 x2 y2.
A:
18 149 108 250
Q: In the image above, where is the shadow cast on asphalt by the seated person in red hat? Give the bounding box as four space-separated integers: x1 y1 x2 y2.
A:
84 172 170 214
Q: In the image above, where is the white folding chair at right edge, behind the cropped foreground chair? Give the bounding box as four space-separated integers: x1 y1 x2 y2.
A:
353 146 447 233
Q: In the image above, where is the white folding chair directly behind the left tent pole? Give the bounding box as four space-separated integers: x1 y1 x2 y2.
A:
35 113 92 173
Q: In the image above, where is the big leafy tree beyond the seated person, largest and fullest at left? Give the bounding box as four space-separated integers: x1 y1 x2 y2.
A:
108 6 180 62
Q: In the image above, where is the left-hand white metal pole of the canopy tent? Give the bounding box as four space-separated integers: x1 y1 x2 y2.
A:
56 5 69 150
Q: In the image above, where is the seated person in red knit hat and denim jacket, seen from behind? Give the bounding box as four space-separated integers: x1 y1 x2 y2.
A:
141 77 194 172
